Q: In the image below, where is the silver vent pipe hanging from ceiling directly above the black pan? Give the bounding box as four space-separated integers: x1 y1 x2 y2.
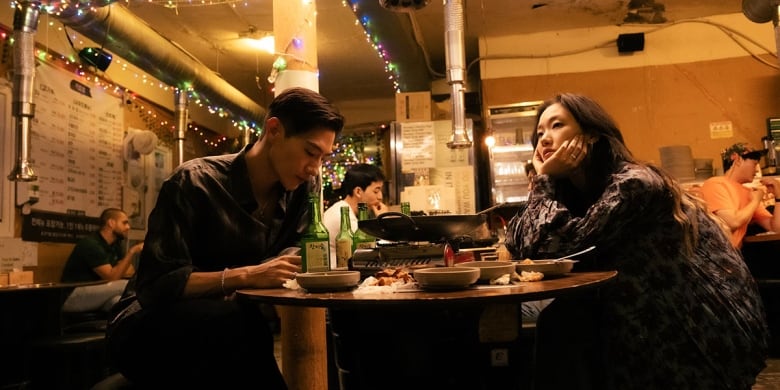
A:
444 0 471 149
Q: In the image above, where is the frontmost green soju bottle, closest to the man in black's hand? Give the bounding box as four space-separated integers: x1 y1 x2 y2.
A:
301 192 330 272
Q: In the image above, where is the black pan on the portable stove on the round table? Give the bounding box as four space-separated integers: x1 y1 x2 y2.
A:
358 211 487 242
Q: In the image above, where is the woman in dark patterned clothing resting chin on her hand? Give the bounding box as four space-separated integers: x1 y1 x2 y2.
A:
507 94 768 390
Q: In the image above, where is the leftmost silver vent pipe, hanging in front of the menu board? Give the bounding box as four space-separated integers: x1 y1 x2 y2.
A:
8 1 41 181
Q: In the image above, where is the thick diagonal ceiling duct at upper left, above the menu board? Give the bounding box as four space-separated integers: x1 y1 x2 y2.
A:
53 4 265 122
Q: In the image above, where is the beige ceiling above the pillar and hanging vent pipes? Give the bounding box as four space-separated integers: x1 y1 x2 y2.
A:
3 0 741 125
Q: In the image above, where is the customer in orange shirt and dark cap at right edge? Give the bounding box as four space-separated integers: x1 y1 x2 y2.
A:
700 143 780 248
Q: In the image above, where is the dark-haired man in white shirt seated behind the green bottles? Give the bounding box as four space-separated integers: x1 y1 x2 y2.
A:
322 164 387 251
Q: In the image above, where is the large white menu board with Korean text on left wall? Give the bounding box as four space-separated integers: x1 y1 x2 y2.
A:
28 63 124 216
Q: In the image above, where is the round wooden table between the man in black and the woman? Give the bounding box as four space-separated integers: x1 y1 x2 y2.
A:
236 271 617 390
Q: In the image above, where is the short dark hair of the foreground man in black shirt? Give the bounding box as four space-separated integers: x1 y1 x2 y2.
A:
265 87 344 137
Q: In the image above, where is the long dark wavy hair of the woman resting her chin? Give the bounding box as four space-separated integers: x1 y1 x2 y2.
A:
532 93 708 254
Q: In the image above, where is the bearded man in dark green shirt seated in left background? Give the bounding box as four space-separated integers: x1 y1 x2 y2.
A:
60 208 143 312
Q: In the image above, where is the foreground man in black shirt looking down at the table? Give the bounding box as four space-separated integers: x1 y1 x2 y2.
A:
108 88 344 389
